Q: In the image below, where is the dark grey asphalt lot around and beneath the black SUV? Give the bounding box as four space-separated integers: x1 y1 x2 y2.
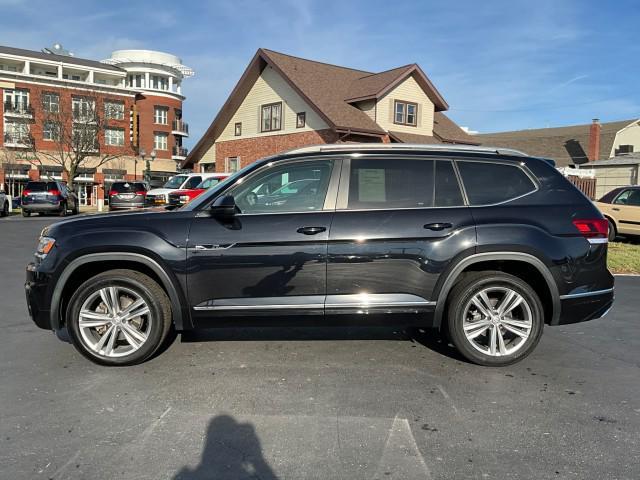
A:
0 217 640 480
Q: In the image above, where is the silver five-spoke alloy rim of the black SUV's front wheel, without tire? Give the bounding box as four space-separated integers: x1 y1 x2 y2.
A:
78 286 153 358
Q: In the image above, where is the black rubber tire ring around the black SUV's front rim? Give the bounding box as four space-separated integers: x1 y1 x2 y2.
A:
66 275 164 366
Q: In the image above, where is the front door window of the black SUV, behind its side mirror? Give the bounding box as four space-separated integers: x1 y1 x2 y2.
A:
229 160 332 213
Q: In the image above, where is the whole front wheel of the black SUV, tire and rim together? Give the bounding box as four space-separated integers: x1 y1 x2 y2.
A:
66 270 171 366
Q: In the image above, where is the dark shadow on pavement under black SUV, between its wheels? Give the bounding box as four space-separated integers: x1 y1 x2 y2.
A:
180 325 467 363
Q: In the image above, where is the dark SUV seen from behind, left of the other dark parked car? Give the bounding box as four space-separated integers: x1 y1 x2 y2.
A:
21 180 80 217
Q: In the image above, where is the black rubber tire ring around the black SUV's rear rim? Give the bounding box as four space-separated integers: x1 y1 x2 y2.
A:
448 275 544 367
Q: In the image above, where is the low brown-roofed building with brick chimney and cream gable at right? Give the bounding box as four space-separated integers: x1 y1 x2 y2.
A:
473 119 640 167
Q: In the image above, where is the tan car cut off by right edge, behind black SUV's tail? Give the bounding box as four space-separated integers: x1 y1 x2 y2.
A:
596 185 640 241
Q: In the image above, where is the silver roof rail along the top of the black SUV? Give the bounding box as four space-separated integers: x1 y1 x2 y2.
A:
284 143 529 157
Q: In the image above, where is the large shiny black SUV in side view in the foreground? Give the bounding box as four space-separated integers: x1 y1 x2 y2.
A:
25 144 613 365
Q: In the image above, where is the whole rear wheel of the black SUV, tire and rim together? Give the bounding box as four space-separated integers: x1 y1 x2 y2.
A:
447 271 544 367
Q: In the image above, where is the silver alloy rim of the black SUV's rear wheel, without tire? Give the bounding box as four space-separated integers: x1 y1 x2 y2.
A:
462 287 533 357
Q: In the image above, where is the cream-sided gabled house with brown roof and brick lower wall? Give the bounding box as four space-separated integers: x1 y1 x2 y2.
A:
183 49 479 171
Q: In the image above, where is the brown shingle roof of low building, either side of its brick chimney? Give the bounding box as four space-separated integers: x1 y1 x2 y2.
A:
474 120 638 167
